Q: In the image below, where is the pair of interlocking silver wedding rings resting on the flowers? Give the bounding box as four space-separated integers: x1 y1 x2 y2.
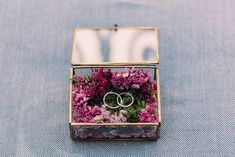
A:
103 92 134 109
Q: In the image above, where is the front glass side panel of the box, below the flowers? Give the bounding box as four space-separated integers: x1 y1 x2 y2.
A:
71 125 159 140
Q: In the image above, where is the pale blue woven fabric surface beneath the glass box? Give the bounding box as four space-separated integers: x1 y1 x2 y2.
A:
0 0 235 157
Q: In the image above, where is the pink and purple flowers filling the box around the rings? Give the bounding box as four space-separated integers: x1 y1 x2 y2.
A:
72 68 157 123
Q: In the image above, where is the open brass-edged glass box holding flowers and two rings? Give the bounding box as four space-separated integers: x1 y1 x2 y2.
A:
69 27 161 141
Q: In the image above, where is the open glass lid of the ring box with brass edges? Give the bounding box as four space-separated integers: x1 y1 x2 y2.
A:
71 27 159 65
